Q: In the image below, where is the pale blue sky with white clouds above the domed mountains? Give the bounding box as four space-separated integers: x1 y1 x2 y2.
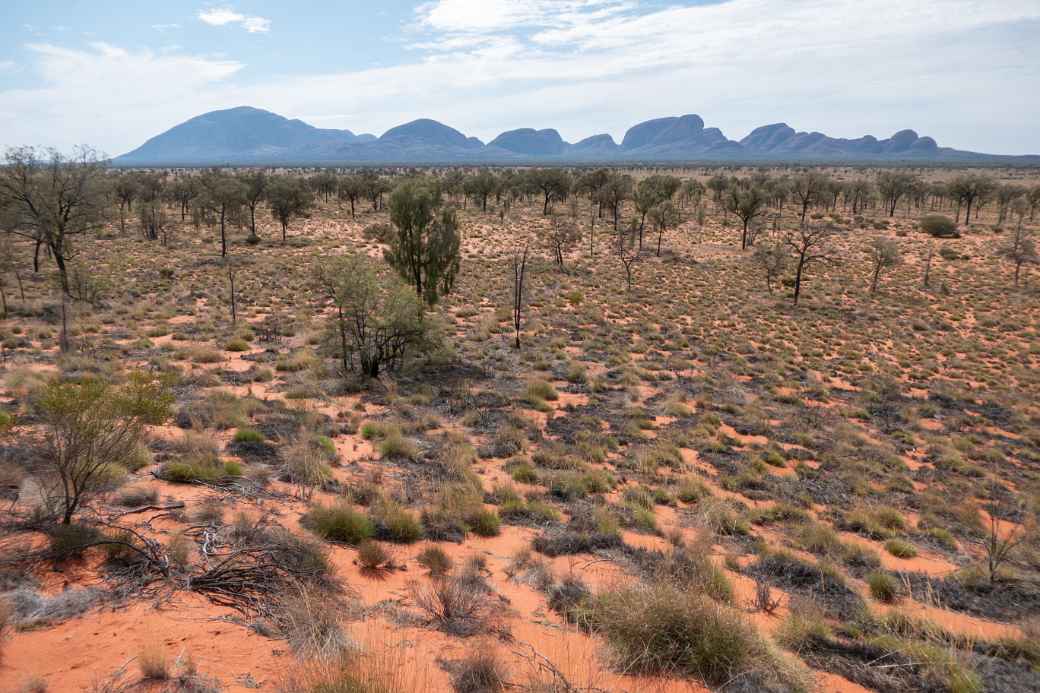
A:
0 0 1040 156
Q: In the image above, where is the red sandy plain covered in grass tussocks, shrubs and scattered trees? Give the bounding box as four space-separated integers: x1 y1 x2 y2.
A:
0 149 1040 693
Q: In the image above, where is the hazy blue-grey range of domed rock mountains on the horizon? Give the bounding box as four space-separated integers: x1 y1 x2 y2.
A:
113 106 1040 166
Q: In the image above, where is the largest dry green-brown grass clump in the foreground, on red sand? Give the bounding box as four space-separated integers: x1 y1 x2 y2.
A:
590 584 809 691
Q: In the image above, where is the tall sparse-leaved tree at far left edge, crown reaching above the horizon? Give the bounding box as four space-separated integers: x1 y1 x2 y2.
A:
0 147 105 293
